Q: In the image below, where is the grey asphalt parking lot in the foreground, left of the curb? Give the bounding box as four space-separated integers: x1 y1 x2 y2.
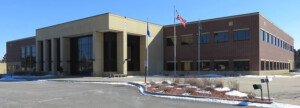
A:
0 81 254 108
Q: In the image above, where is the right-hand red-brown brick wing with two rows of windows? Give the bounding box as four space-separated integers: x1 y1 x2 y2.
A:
164 13 294 75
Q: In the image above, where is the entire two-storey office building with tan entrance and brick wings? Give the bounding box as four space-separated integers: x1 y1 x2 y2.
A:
7 13 294 76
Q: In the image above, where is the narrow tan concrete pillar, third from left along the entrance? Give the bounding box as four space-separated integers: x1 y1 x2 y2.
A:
51 38 58 75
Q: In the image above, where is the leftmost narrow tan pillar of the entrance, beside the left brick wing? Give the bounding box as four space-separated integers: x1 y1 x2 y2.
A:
35 41 42 72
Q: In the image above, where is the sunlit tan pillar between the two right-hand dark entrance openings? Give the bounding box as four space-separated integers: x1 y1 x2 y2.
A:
117 31 127 75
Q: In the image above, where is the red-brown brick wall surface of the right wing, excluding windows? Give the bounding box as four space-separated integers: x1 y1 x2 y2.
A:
164 13 293 71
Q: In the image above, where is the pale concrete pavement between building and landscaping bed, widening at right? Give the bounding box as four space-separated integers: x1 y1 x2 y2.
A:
48 77 300 105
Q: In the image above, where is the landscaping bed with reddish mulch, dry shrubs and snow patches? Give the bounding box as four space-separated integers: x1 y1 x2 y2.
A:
145 78 272 102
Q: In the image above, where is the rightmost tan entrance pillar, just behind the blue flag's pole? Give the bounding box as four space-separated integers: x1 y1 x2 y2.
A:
140 36 146 75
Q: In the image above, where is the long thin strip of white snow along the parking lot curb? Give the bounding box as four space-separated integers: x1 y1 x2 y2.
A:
39 80 300 108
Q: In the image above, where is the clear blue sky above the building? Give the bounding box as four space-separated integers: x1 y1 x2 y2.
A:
0 0 300 59
